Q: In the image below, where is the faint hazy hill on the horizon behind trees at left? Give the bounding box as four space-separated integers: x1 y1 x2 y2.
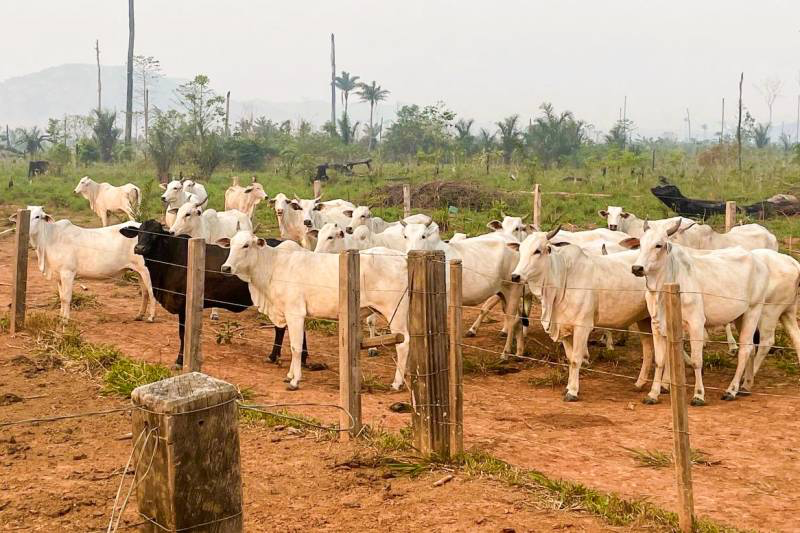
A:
0 64 394 128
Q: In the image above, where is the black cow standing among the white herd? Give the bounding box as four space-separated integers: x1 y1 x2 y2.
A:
119 220 308 367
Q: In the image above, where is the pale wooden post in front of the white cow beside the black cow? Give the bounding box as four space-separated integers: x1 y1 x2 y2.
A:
339 250 361 440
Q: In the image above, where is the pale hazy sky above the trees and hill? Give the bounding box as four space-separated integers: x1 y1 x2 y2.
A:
0 0 800 137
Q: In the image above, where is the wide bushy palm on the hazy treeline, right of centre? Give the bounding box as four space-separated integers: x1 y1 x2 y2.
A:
525 102 588 167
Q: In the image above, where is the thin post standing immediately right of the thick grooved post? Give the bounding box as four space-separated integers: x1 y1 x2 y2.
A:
447 259 464 457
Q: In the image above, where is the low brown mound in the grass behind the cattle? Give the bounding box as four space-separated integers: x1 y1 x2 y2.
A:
371 180 498 210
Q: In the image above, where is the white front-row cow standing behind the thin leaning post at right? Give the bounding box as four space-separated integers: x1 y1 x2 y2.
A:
631 221 769 405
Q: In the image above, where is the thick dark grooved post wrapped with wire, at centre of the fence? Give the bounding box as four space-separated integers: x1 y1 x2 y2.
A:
408 250 451 457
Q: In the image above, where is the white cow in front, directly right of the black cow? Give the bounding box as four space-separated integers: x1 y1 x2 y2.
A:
218 231 409 390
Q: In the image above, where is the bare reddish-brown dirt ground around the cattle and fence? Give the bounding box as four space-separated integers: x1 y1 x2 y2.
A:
0 210 800 531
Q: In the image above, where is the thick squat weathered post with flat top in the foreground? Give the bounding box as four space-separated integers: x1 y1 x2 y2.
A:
131 372 243 533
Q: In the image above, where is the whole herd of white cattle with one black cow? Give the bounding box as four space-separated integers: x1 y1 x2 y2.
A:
12 177 800 405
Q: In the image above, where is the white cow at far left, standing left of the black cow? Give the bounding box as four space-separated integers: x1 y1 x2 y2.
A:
11 205 156 322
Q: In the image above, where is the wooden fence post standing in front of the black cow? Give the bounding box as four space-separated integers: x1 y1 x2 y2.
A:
183 238 206 372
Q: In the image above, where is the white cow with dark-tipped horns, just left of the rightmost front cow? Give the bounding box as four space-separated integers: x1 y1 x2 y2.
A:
509 228 653 402
